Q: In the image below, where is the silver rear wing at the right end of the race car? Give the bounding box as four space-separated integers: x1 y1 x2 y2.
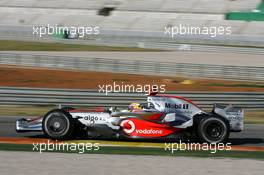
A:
213 104 244 132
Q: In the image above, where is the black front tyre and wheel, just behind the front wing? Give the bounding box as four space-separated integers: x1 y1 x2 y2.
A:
42 109 74 140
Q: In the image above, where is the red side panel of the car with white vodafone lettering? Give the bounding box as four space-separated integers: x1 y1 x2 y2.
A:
120 118 181 138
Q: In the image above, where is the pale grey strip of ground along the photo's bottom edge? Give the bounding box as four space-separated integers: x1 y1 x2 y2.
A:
0 151 264 175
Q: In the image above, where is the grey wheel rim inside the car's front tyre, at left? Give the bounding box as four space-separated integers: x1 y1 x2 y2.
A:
46 113 69 135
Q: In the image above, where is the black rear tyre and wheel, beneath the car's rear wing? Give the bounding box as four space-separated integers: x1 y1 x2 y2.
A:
197 116 230 143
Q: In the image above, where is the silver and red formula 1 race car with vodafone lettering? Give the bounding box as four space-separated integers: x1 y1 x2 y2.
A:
16 94 244 143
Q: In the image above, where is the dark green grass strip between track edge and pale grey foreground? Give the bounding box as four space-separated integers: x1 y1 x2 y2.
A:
0 144 264 160
